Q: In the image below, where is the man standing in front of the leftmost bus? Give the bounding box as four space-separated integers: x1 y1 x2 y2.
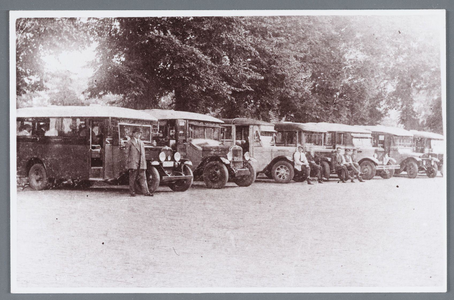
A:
126 128 153 197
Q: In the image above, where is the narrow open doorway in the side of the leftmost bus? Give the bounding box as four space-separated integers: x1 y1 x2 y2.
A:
89 119 106 180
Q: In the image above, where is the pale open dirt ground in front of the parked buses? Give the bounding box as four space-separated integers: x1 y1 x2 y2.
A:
13 176 446 288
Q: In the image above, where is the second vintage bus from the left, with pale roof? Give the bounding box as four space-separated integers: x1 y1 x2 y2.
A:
145 109 256 189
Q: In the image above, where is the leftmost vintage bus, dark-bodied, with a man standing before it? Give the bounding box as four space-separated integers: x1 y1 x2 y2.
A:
16 106 193 192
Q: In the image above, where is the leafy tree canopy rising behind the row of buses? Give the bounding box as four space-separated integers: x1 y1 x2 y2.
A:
16 16 442 132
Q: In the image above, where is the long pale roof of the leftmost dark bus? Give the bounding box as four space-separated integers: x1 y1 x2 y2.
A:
16 105 158 122
